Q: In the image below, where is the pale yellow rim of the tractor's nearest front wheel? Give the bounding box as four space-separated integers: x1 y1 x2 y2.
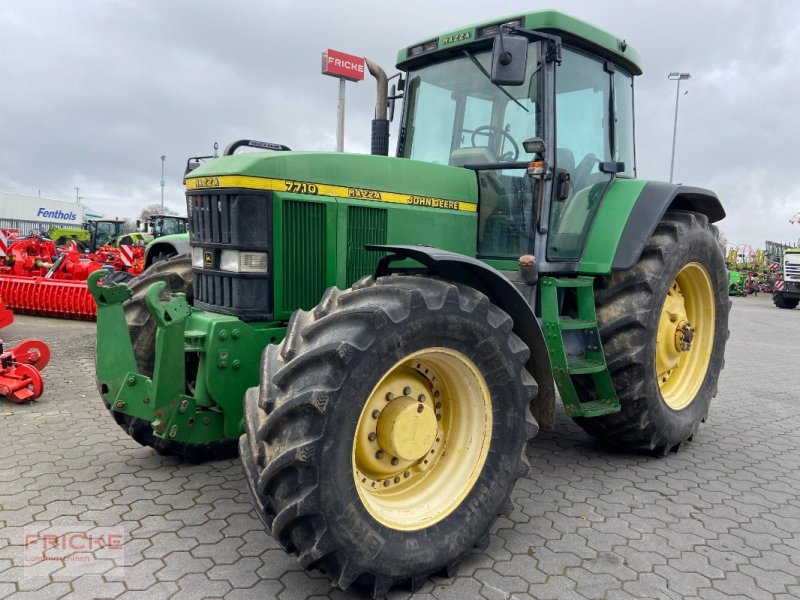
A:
352 348 492 531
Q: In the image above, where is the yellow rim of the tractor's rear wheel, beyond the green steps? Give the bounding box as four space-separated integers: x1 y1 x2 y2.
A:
656 262 715 410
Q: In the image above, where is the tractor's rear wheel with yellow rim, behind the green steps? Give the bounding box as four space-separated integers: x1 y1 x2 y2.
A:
575 211 730 455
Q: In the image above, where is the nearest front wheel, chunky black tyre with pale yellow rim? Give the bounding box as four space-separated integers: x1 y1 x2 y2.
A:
240 276 535 597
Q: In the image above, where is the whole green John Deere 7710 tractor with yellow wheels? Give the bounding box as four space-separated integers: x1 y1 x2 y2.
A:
90 11 729 596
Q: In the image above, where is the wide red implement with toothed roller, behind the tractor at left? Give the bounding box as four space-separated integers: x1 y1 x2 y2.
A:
0 235 108 320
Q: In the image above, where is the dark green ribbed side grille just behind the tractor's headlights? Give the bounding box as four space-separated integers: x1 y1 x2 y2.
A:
283 200 327 311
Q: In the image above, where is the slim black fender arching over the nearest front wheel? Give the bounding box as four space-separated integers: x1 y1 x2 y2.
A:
365 245 555 429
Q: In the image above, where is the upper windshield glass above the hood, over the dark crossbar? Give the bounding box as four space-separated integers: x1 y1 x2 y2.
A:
401 44 538 166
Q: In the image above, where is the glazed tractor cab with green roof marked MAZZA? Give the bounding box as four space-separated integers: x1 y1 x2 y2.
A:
398 12 641 271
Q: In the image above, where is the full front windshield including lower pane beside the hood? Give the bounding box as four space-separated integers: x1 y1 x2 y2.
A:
400 43 541 258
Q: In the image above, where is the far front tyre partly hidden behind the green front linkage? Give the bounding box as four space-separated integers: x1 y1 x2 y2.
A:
111 254 238 463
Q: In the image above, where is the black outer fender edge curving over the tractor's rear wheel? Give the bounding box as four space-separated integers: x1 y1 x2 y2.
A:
611 181 725 271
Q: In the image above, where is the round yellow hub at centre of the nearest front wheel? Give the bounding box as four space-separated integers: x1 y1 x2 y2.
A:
377 396 436 461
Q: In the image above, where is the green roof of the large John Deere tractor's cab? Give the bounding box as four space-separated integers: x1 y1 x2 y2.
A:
397 10 642 75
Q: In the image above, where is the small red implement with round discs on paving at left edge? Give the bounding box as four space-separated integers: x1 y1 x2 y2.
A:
0 298 50 403
